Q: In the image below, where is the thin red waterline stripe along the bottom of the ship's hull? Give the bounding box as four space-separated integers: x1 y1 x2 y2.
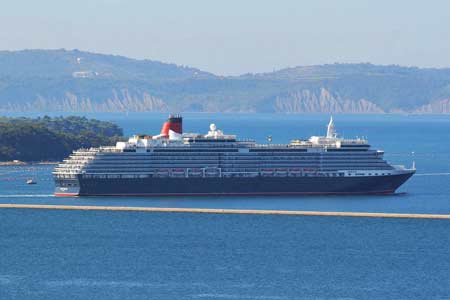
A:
55 190 394 197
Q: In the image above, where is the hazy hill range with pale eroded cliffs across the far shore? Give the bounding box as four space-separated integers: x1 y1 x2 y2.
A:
0 50 450 114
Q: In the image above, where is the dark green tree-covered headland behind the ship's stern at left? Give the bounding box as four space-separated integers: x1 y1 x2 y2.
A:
0 116 123 162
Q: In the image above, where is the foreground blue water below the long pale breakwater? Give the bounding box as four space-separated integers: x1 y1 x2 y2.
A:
0 209 450 300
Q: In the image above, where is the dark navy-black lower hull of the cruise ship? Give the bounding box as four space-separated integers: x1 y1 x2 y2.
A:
55 172 414 196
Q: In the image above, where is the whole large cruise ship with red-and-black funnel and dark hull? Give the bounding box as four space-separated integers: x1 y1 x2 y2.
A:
53 115 415 196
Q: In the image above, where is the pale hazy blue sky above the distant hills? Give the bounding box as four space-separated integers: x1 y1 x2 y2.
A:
0 0 450 74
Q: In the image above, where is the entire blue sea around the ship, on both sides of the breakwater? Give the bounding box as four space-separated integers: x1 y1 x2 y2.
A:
0 113 450 300
